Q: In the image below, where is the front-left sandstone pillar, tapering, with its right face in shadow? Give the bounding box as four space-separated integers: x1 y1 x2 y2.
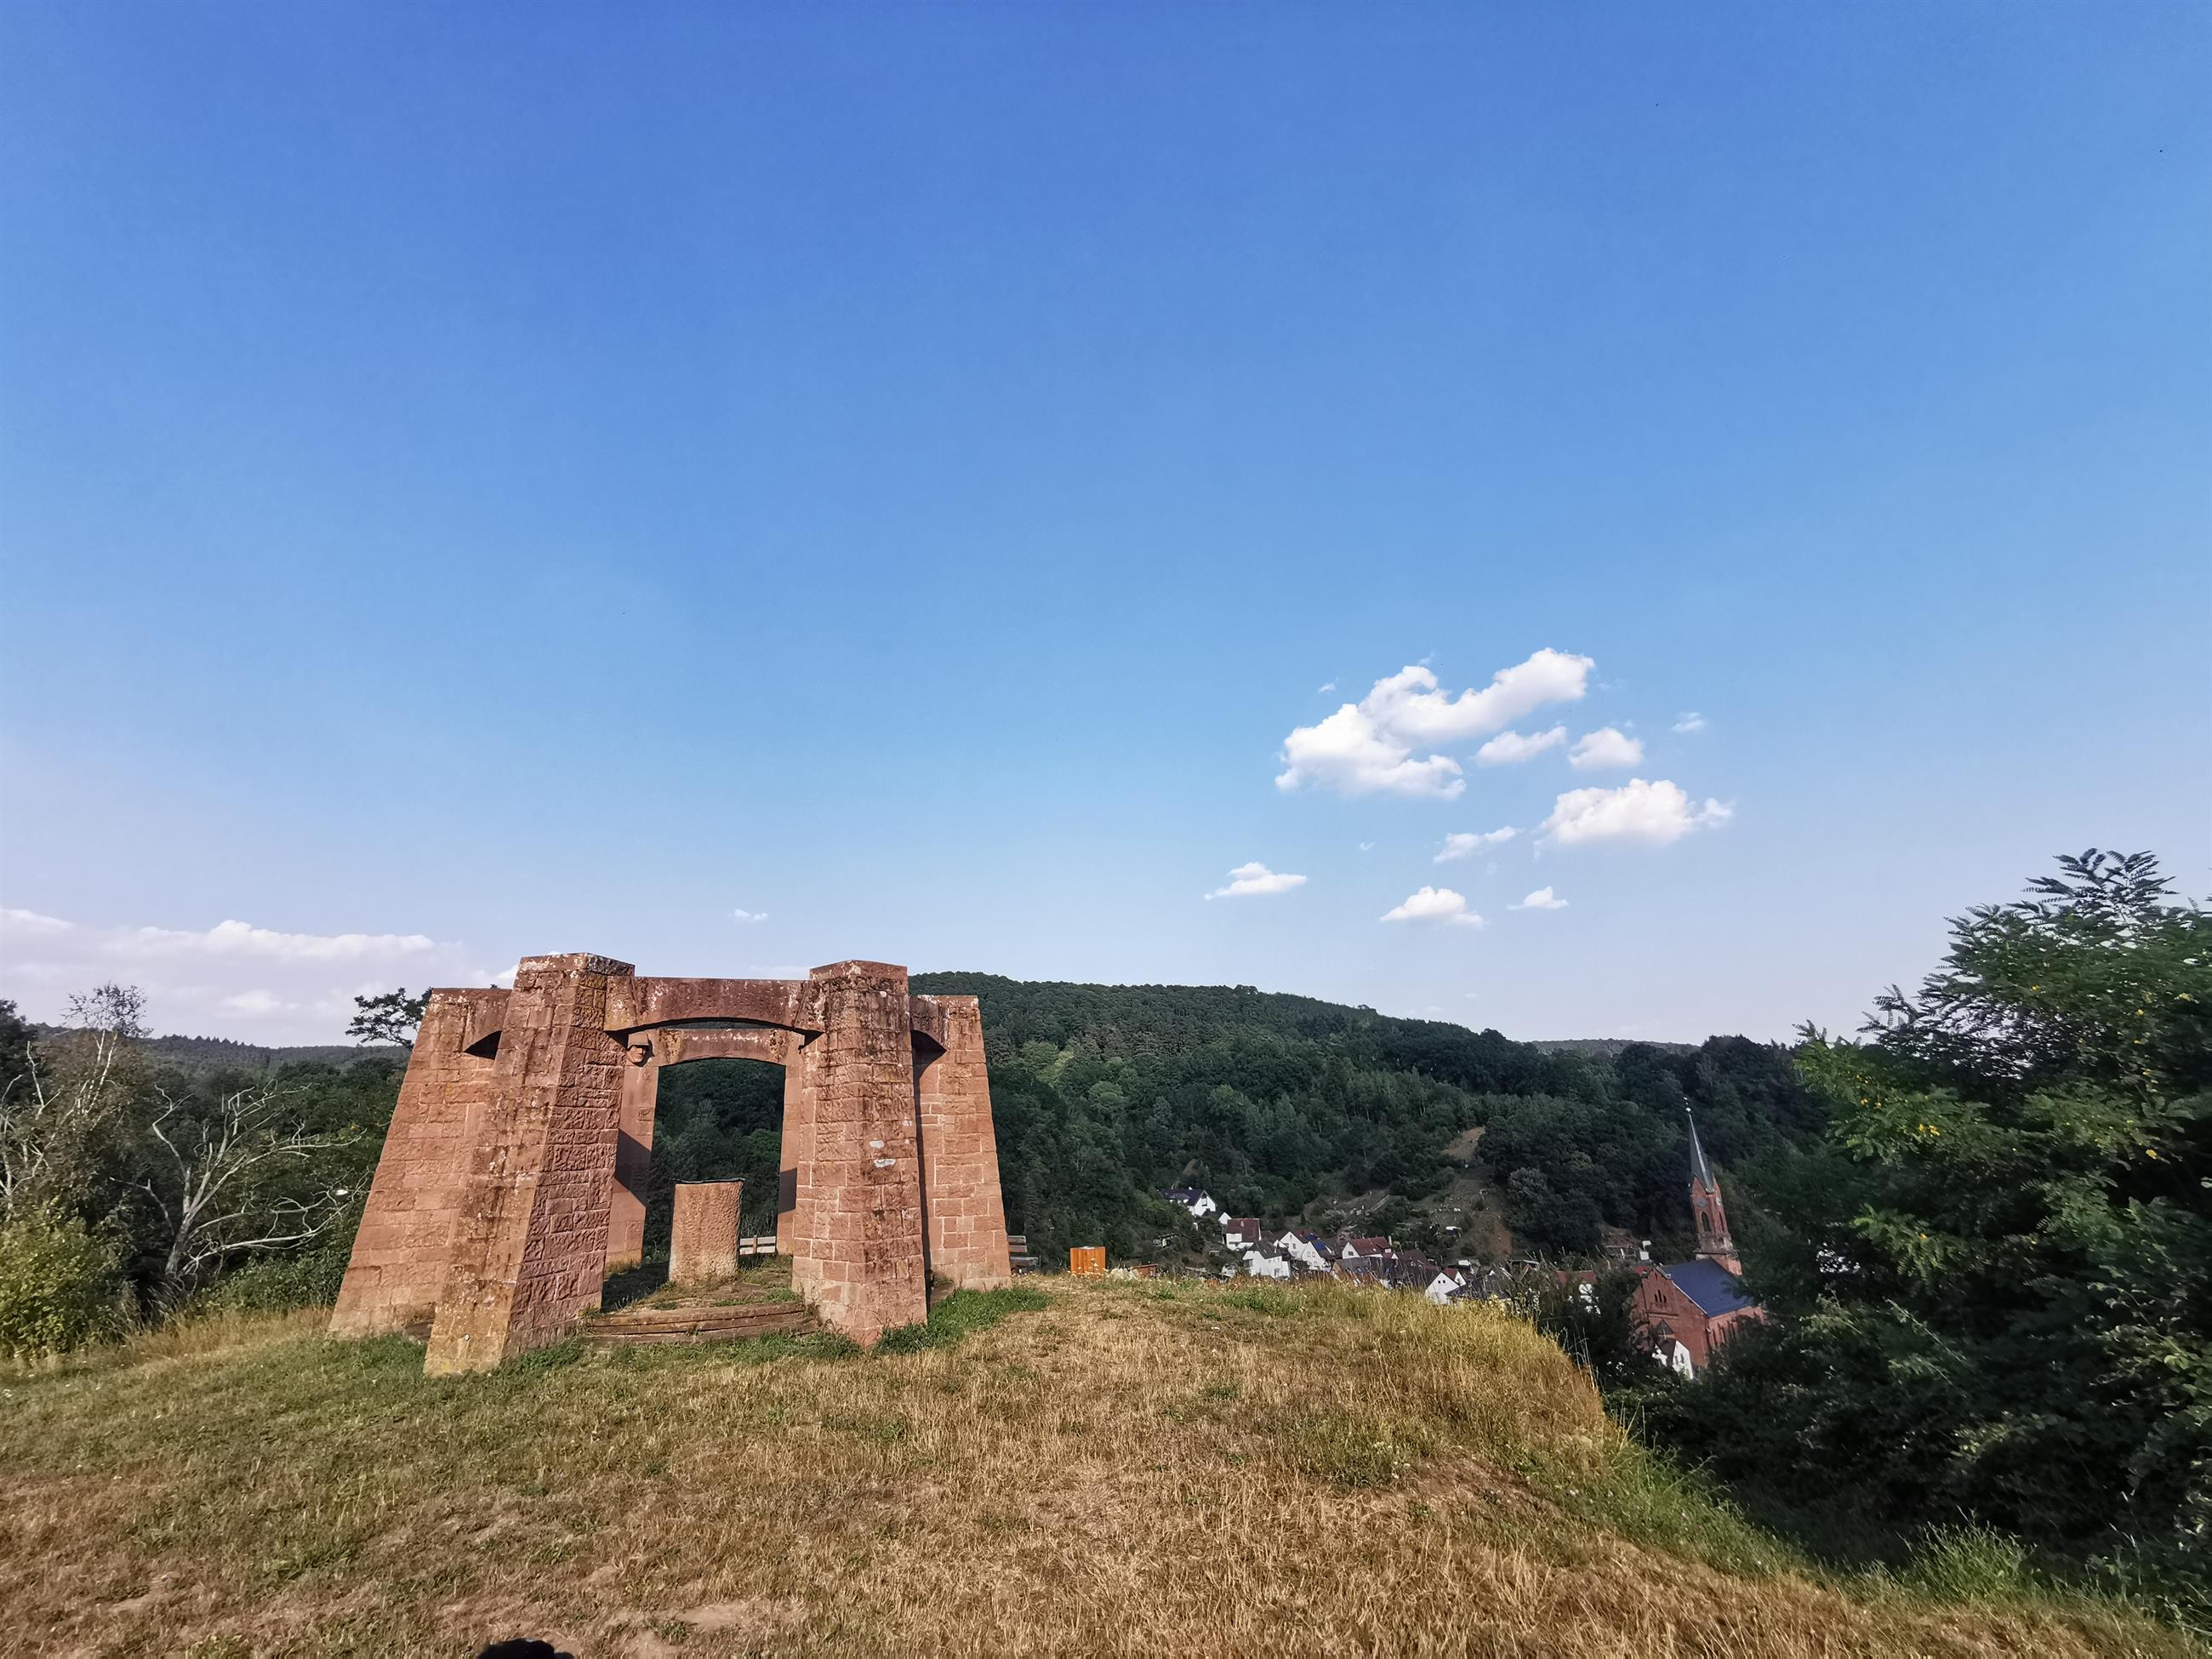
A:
423 955 633 1374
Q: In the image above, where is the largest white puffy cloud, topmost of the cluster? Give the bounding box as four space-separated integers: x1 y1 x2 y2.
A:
1274 648 1597 801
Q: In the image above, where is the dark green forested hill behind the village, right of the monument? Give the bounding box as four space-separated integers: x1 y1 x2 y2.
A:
914 973 1821 1254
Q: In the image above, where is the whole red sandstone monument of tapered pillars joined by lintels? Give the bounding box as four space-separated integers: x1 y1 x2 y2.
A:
329 955 1011 1371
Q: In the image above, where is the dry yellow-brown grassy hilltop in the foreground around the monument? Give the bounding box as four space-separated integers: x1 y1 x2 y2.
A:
0 1280 2181 1655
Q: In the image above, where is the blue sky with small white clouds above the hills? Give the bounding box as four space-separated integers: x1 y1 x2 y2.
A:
0 0 2212 1040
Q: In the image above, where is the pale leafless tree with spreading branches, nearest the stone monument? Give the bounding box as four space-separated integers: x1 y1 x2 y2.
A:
140 1086 350 1308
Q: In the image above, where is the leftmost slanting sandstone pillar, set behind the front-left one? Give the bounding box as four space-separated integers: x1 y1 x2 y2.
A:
329 991 506 1336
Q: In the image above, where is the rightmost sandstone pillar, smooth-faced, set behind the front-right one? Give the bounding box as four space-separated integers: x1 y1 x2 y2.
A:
915 998 1013 1290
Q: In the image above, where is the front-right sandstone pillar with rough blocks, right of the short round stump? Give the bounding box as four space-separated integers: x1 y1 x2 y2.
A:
792 962 929 1343
